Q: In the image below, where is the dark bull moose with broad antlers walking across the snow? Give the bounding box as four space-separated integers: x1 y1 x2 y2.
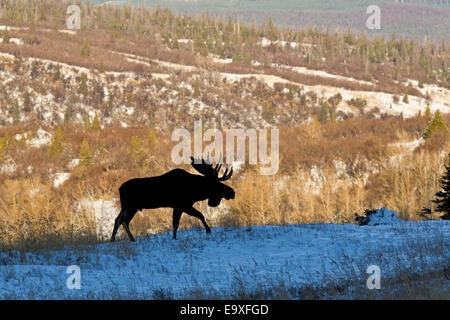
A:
111 157 235 242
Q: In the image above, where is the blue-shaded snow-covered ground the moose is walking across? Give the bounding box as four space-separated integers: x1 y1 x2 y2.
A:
0 216 450 299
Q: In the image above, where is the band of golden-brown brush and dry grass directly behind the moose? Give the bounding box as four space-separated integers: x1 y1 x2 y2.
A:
0 117 450 250
